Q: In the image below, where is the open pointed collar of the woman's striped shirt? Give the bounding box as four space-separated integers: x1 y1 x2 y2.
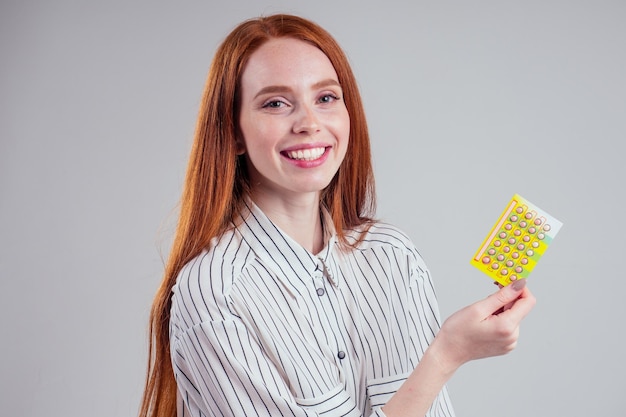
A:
236 198 339 294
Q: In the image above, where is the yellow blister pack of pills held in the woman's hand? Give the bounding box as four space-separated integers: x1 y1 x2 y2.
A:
471 194 563 286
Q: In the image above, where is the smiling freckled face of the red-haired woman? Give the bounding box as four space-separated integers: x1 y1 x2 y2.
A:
239 38 350 204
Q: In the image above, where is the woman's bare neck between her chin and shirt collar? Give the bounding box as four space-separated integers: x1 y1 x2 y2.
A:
252 193 324 254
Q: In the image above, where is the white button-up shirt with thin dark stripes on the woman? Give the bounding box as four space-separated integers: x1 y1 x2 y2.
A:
170 201 454 417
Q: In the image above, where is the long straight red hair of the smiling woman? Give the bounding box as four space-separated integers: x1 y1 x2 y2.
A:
139 15 375 417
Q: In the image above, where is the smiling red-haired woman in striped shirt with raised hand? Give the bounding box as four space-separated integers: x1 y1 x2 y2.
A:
141 15 534 417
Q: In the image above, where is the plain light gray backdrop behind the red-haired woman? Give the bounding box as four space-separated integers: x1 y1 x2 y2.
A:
0 0 626 417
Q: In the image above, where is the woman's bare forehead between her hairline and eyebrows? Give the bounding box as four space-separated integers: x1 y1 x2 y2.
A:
241 38 338 94
